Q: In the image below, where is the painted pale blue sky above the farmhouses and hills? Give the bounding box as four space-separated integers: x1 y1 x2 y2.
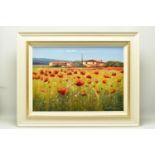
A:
33 47 123 62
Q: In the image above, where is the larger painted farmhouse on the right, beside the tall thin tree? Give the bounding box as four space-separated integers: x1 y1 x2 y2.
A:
82 60 105 67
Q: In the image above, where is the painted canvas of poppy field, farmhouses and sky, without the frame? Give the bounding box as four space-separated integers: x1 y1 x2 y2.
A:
32 46 124 112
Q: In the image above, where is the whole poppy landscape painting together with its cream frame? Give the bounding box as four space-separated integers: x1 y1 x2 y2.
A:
17 32 139 126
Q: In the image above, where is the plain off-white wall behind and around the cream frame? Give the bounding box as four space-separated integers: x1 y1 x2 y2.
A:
0 27 155 128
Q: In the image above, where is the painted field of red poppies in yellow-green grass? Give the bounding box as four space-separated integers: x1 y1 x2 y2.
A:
32 66 124 111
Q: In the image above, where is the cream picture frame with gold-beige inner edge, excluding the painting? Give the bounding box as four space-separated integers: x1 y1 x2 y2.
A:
17 32 139 126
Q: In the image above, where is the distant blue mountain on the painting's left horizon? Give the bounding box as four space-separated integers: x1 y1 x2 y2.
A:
33 58 70 65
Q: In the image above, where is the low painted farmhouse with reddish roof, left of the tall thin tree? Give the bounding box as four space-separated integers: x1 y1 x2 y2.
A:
48 61 73 67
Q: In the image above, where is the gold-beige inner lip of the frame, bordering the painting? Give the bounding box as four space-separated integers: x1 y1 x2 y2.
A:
26 41 130 119
